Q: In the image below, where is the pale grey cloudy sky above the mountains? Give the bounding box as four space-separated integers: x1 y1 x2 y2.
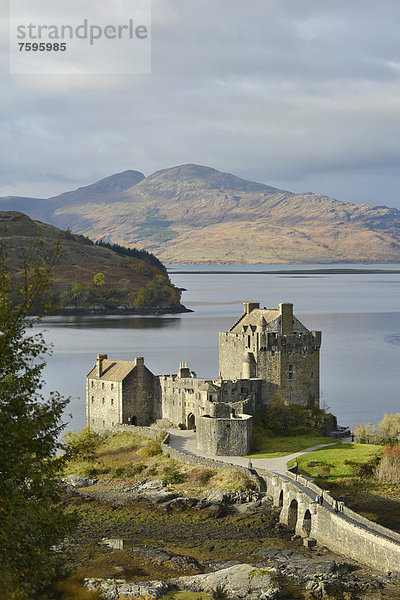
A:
0 0 400 208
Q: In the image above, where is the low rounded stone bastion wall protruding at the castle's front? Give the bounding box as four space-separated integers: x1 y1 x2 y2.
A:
197 415 253 456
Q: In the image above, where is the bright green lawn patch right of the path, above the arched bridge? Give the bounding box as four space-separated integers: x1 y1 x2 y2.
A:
288 442 383 484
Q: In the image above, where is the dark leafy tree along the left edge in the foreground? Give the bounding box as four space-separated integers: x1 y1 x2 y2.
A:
0 240 69 600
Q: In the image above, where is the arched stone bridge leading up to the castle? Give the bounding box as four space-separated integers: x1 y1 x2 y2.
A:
162 434 400 575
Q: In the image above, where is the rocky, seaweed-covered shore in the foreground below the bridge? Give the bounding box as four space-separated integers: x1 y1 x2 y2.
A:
65 476 400 600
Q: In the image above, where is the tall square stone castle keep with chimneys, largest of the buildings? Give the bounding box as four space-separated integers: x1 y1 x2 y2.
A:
219 302 321 406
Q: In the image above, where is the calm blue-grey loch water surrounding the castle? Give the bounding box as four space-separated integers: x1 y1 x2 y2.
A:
35 265 400 430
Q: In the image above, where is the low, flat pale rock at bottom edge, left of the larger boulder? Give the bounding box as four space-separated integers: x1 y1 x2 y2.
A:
84 579 168 600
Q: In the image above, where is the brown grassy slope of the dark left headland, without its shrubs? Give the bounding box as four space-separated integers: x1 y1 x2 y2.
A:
0 212 179 308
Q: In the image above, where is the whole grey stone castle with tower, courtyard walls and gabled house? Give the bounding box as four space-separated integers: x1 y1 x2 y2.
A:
86 302 321 455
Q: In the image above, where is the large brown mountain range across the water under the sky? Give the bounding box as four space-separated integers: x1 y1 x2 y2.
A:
0 164 400 263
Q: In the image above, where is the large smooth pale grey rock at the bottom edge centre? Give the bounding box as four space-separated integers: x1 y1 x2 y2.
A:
171 564 279 600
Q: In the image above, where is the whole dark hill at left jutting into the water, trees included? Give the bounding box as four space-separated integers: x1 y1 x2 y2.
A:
0 211 186 313
